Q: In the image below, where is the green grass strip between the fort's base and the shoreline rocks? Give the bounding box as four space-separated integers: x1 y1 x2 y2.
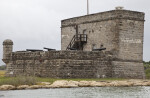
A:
0 76 125 86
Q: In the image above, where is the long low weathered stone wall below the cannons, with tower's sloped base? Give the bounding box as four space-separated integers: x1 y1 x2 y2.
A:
4 51 144 78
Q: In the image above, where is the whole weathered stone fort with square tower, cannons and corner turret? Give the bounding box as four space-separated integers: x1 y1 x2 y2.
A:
3 7 145 79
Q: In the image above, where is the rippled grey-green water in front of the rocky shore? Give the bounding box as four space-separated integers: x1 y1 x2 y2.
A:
0 87 150 98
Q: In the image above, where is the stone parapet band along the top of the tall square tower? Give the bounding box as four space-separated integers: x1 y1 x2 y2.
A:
61 7 145 28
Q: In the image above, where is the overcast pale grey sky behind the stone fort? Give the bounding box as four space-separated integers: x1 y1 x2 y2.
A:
0 0 150 65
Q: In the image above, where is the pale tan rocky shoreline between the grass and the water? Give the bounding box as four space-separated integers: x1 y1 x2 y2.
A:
0 79 150 91
